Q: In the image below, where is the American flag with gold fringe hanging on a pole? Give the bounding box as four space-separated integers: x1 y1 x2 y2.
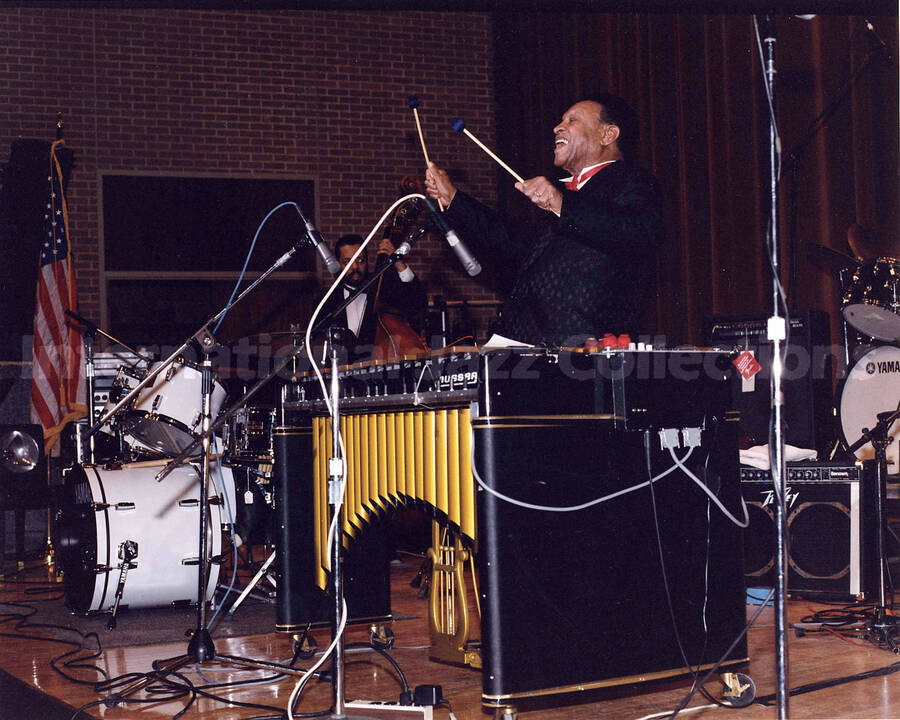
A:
31 140 87 452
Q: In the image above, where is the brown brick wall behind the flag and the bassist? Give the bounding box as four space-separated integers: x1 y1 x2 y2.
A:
0 7 496 348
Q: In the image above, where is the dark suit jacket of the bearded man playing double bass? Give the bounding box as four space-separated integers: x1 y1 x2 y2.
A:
319 258 425 362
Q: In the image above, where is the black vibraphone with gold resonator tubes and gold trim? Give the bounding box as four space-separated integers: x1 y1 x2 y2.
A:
275 348 746 707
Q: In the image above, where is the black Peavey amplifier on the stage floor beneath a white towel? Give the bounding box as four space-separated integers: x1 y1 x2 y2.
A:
741 462 878 599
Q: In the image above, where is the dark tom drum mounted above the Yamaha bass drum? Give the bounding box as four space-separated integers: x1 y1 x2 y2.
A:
843 258 900 342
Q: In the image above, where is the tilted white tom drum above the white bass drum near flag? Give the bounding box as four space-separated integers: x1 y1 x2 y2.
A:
123 362 226 455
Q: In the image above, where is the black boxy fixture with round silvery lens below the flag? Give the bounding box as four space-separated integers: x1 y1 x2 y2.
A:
0 424 50 508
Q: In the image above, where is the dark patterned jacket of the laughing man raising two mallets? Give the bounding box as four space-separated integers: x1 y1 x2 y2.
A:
446 162 663 345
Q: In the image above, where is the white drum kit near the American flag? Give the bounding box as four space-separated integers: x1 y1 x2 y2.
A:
56 338 274 628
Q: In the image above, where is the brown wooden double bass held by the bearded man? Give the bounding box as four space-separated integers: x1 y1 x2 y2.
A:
373 175 429 361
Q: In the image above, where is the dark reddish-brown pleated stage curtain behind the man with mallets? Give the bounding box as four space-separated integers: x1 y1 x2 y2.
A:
494 12 900 352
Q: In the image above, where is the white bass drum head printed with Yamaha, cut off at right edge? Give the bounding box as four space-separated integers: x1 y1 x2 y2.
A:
839 345 900 475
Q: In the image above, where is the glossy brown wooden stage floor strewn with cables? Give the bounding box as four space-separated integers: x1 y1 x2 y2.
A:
0 558 900 720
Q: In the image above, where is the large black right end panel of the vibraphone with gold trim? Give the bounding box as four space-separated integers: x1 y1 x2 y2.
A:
472 351 747 706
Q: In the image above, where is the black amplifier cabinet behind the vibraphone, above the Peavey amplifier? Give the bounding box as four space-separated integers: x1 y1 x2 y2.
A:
703 310 834 457
